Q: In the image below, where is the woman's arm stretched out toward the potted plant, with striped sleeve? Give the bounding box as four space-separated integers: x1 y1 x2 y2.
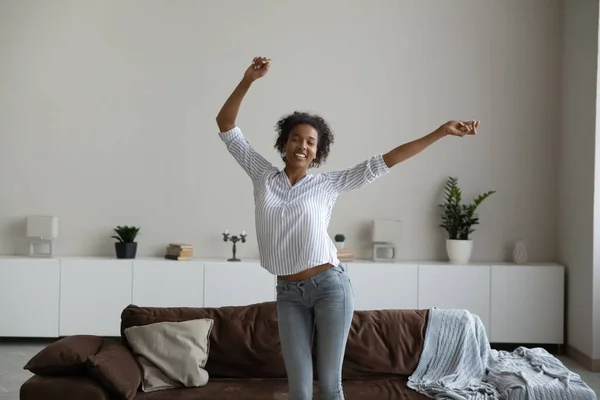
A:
325 121 479 192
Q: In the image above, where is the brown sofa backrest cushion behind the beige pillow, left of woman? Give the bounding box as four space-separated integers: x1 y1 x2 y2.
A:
121 302 286 379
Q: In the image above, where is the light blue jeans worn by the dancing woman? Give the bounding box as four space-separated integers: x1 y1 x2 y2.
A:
277 265 354 400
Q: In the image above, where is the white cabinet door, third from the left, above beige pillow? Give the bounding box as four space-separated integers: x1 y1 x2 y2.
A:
133 260 204 307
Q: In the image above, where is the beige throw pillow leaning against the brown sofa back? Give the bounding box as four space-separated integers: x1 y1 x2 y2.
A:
125 318 214 392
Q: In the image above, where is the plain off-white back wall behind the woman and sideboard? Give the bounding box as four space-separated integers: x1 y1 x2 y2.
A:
0 0 564 262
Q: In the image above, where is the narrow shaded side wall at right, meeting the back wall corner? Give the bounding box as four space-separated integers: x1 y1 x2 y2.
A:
558 0 600 358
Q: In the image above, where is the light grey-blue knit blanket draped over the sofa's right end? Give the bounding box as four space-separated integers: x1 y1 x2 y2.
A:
408 308 597 400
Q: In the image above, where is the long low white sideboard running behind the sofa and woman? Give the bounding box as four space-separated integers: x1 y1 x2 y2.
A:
0 257 565 344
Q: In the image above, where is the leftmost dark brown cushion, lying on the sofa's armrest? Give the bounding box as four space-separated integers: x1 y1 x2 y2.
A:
23 335 103 376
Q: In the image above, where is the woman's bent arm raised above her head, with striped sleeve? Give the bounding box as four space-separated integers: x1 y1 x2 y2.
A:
217 57 272 180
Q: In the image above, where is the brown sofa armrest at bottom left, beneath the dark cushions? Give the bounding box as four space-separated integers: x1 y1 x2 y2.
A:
19 375 110 400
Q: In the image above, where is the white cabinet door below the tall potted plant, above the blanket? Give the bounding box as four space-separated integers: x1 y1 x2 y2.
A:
419 264 491 337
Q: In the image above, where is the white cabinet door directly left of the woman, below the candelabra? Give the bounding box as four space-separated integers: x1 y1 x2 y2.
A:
204 261 276 307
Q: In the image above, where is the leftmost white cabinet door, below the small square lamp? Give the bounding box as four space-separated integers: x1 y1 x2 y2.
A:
0 259 60 337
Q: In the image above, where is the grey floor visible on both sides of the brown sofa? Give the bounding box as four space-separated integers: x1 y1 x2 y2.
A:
0 341 600 400
